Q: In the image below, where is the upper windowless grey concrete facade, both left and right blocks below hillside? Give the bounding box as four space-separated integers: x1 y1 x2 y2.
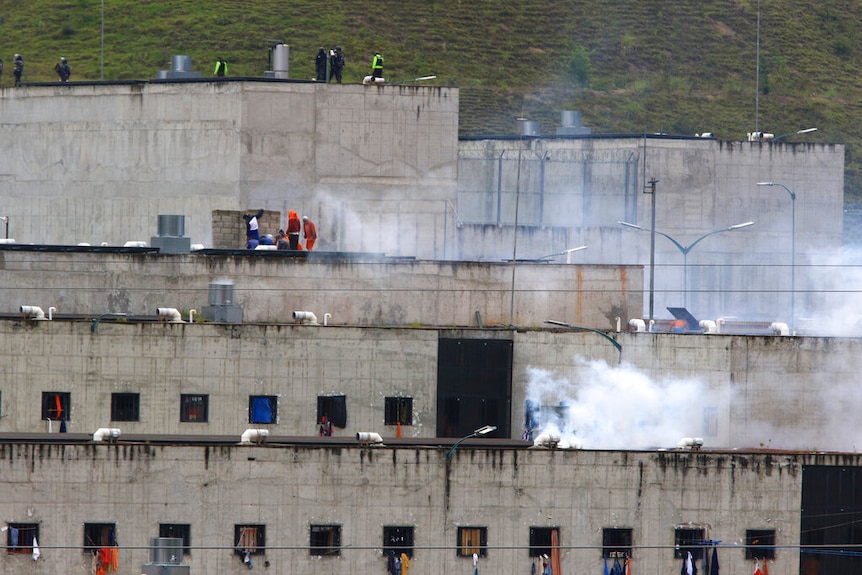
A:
0 80 844 324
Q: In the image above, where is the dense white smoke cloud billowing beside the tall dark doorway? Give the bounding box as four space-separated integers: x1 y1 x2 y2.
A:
526 358 708 449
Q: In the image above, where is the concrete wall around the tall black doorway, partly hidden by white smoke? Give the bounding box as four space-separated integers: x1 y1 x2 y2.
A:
0 320 862 451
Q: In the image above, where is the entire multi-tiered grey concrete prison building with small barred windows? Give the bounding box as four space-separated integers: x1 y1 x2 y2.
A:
0 74 862 575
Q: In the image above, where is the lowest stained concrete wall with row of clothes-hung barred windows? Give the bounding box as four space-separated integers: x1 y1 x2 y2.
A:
0 442 816 575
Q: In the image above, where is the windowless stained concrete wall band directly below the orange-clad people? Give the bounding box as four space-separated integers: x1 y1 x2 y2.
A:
0 251 643 329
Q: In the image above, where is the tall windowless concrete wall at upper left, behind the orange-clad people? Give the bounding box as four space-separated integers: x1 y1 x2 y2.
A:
0 80 458 257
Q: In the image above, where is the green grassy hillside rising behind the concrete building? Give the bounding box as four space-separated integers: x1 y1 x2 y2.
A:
0 0 862 203
